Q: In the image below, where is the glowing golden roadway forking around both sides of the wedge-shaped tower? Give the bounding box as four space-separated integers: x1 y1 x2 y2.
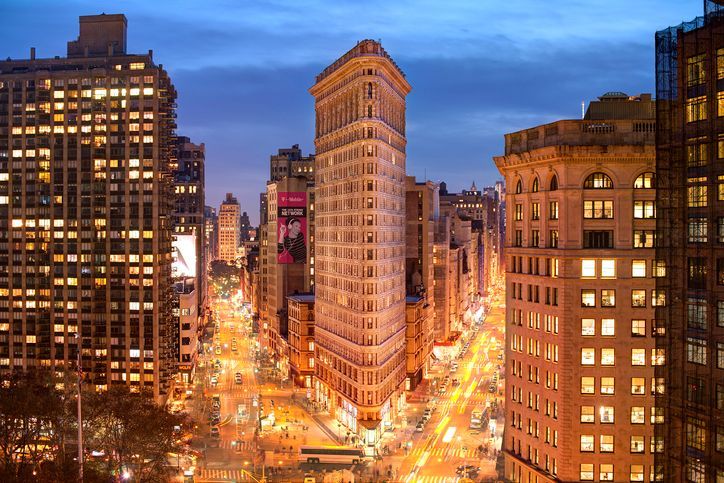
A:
185 290 505 483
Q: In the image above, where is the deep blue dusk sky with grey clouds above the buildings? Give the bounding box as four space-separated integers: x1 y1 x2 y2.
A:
0 0 703 223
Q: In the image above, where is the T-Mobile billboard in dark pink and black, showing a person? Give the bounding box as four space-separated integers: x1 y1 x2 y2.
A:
277 191 307 264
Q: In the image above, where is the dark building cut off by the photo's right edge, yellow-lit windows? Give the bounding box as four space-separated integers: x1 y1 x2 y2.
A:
656 1 724 483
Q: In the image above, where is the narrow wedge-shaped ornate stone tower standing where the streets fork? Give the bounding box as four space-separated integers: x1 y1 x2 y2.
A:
310 40 410 447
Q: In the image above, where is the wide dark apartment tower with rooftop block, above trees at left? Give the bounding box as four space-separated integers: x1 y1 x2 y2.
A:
0 15 176 400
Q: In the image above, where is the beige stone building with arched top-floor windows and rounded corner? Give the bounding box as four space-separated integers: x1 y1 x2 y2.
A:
495 93 666 482
